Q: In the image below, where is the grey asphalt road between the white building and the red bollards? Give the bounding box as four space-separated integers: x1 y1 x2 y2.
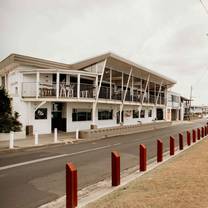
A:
0 120 205 208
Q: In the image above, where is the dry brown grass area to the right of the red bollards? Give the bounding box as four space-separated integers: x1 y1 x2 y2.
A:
87 140 208 208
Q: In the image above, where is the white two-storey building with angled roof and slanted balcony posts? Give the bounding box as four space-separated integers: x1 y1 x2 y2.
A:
0 53 175 134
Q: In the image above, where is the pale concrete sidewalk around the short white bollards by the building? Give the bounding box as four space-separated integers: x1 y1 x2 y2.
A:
0 132 77 151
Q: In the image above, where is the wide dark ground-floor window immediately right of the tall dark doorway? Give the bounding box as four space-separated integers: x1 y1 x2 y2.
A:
72 109 92 121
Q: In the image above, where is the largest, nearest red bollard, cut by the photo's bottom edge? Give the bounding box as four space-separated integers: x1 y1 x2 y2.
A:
66 162 77 208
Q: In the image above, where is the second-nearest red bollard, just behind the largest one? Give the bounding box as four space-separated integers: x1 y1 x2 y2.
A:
111 151 120 186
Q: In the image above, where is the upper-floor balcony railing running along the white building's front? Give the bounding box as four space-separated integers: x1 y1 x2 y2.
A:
22 82 165 105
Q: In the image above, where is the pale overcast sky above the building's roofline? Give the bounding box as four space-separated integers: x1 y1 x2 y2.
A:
0 0 208 104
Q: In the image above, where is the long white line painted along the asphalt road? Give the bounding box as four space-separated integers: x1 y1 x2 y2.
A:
0 143 120 171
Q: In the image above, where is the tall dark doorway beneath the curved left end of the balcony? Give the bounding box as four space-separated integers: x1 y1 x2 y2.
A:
51 102 66 131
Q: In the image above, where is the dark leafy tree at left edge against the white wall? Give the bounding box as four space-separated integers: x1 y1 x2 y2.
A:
0 88 22 133
